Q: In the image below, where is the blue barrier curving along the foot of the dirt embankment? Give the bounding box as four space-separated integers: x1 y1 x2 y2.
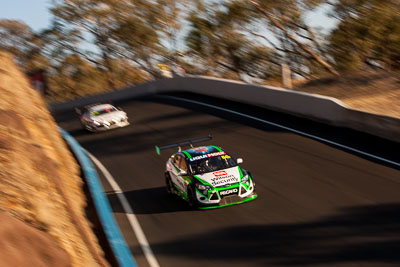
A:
59 128 137 267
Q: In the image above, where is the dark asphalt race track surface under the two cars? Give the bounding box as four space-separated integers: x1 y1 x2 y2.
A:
54 95 400 267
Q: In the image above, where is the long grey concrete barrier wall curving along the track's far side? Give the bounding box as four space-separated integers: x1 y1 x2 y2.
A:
50 77 400 142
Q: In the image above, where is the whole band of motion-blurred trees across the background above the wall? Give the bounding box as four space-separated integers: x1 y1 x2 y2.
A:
0 0 400 100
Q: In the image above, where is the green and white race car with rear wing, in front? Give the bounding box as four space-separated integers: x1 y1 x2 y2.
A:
156 137 257 209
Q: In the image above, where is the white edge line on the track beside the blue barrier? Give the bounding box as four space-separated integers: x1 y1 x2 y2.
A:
83 149 160 267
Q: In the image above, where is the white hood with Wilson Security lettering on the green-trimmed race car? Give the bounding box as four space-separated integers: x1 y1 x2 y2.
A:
196 166 240 187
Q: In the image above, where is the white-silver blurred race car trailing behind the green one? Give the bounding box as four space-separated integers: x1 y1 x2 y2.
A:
75 104 129 132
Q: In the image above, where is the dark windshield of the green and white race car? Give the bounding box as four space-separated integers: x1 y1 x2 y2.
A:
189 155 237 174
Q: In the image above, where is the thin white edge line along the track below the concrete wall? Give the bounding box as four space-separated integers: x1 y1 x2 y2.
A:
162 96 400 167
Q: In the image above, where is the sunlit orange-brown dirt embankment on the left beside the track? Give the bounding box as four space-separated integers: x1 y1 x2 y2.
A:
0 51 109 267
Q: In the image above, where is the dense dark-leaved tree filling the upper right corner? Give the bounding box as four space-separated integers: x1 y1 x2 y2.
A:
329 0 400 71
